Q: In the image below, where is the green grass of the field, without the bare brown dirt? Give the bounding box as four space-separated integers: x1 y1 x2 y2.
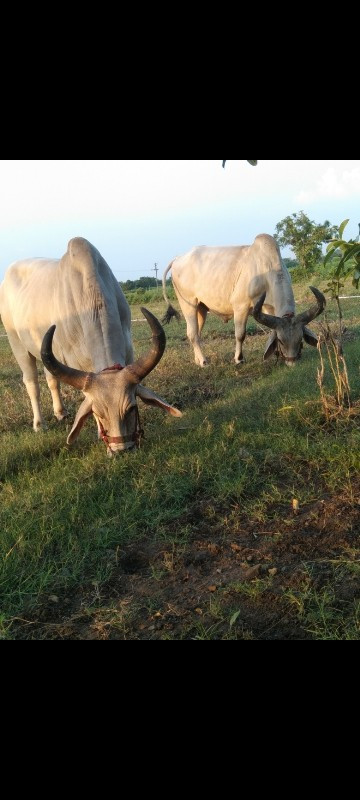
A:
0 285 360 639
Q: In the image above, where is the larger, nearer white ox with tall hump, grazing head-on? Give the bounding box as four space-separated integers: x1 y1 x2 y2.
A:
0 237 181 456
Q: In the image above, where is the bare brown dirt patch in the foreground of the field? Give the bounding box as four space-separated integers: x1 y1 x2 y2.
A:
12 481 360 640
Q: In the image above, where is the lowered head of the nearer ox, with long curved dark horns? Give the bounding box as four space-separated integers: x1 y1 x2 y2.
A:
41 308 182 456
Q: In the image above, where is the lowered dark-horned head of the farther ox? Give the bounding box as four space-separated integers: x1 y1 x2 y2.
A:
253 286 326 367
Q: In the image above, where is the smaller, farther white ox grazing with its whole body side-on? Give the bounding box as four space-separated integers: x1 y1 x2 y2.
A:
163 233 325 367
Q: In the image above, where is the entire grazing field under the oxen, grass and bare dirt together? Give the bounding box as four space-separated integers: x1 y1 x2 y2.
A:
0 283 360 640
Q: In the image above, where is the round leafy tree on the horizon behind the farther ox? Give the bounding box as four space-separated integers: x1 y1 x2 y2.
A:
274 211 339 272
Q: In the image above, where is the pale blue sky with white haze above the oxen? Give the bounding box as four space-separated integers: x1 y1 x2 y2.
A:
0 160 360 281
